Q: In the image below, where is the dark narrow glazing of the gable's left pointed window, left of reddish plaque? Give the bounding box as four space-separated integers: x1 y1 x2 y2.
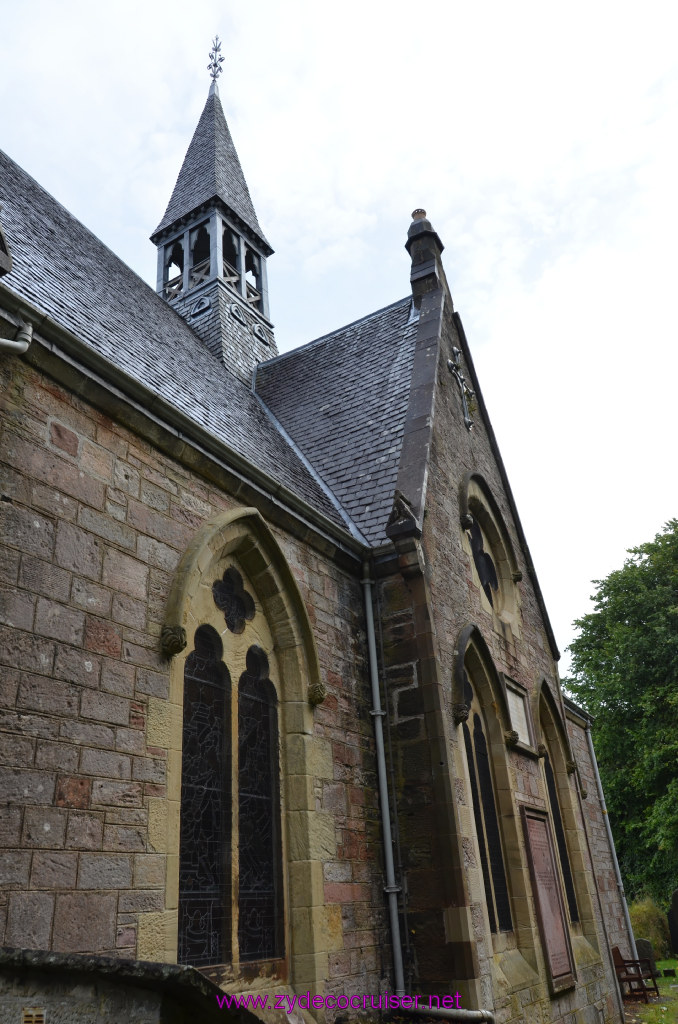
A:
463 679 513 932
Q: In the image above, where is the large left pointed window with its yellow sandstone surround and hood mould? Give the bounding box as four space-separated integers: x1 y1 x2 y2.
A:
162 509 325 983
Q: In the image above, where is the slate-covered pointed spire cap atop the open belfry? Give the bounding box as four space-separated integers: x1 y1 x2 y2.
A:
151 87 272 249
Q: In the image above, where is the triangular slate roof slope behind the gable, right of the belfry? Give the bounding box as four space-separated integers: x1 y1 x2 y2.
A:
256 298 417 544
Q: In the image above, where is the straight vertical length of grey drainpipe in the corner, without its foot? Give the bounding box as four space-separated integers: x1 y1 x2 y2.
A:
361 561 405 996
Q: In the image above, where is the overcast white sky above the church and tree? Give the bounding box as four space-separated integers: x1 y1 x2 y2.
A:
0 0 678 671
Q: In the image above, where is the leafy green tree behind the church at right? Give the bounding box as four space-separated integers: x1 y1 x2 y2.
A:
564 519 678 904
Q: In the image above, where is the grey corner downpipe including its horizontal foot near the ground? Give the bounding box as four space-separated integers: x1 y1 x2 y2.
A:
361 561 495 1024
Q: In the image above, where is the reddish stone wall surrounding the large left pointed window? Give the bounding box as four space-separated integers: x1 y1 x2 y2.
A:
0 358 387 992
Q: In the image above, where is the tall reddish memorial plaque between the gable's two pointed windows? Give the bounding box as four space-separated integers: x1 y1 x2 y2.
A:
520 807 575 994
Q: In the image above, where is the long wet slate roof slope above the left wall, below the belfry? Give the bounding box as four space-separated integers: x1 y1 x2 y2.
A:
0 151 345 526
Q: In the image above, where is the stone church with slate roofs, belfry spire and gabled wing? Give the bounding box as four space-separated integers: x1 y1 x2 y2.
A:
0 44 631 1024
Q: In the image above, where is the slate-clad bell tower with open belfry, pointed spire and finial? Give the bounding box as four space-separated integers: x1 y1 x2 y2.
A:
151 36 278 384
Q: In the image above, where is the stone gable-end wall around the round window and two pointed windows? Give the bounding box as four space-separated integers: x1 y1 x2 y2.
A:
380 276 619 1024
